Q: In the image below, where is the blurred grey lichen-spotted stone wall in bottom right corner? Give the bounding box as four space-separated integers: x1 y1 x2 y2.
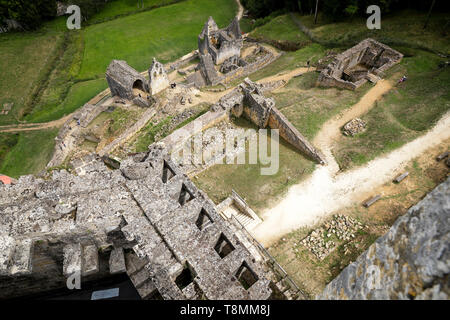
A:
318 178 450 300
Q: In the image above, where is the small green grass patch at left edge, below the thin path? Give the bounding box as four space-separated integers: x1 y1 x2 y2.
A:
0 129 58 178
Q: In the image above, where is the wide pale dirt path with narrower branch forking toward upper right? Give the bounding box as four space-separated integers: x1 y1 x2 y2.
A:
252 81 450 245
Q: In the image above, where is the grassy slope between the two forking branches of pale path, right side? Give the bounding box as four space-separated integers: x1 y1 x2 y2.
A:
334 51 450 169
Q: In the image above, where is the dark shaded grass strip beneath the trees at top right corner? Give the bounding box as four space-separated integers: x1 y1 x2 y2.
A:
297 10 450 54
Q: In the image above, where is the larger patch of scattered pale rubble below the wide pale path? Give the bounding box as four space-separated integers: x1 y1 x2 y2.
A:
300 214 363 260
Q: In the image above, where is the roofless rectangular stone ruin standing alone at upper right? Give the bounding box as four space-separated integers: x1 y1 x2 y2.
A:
317 38 403 90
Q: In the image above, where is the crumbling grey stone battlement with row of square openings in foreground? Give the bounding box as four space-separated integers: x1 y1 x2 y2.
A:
0 144 272 300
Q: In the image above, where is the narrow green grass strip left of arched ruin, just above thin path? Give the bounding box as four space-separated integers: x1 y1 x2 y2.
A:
26 79 107 122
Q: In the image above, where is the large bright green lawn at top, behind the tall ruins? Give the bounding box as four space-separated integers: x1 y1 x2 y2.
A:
79 0 236 78
